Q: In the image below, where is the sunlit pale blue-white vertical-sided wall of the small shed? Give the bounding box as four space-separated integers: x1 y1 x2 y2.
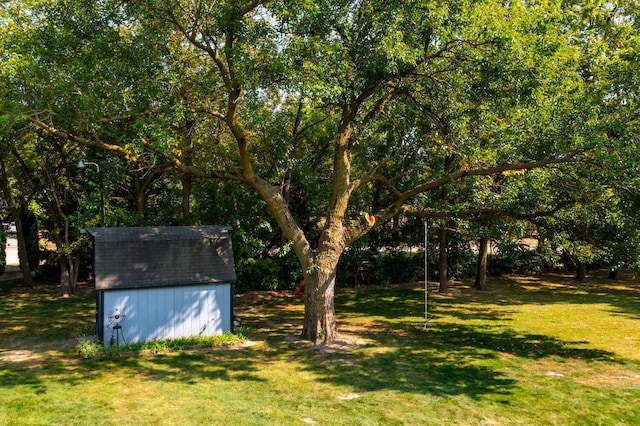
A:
102 283 233 346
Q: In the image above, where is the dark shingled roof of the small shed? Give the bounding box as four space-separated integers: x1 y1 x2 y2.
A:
87 226 236 290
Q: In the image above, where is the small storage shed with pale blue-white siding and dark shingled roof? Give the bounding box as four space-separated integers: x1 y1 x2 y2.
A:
87 226 236 346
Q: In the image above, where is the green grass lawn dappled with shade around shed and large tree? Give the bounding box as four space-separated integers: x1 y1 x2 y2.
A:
0 275 640 425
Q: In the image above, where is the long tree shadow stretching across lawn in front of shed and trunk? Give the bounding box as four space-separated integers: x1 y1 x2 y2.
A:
0 318 620 399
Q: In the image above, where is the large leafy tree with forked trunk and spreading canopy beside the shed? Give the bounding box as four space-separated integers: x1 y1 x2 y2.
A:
2 0 632 342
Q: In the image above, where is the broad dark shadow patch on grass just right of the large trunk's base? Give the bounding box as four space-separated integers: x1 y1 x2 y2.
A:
292 318 613 399
